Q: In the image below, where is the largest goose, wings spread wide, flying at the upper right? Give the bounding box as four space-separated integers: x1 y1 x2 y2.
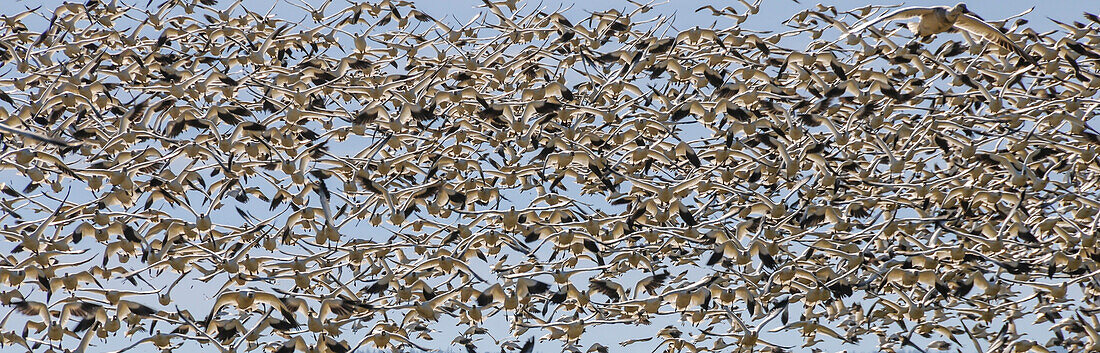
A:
847 2 1038 66
